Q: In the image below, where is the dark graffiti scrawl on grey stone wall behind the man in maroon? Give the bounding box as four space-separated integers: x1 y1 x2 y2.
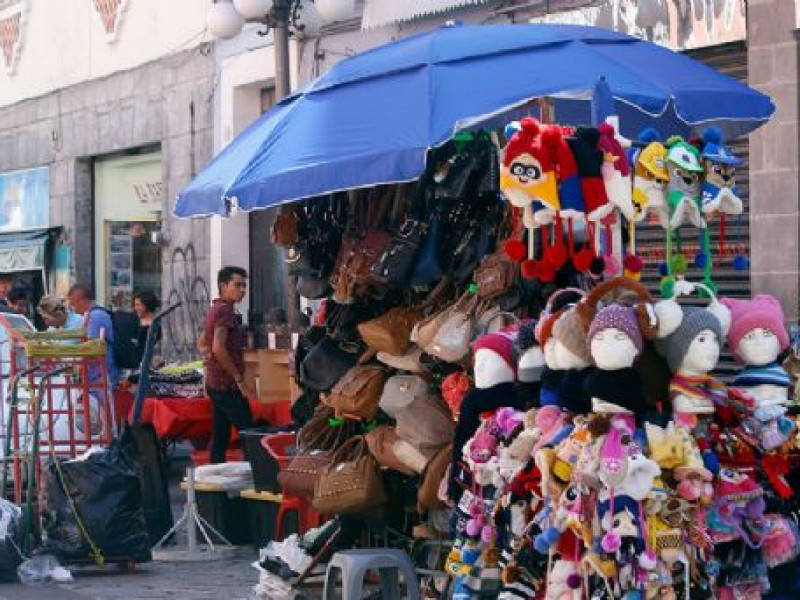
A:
164 242 211 359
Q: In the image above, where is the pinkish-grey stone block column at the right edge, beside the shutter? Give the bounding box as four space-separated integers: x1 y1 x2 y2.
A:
747 0 800 322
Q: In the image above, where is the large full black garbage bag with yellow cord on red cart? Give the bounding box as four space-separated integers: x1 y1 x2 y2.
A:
41 442 152 562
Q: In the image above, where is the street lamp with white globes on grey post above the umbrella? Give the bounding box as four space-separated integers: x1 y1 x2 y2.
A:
207 0 355 100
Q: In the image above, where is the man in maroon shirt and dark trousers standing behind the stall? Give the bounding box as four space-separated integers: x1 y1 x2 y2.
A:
198 267 255 463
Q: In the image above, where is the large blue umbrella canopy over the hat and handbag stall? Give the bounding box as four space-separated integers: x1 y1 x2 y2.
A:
174 25 775 217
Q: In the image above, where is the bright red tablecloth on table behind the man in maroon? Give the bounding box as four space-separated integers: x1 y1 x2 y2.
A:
133 398 290 441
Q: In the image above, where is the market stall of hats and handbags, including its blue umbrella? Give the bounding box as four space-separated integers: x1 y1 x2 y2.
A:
170 21 800 599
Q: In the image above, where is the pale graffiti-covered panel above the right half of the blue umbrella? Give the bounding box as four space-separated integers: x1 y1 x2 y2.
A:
532 0 747 50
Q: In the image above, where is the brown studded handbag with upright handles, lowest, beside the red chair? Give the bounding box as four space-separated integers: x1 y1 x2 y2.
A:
312 436 387 515
